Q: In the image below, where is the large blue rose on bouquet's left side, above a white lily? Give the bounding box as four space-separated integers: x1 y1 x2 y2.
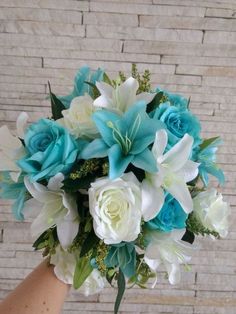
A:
18 119 79 181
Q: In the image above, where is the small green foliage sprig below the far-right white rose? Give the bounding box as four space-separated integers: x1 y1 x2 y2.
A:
186 212 220 238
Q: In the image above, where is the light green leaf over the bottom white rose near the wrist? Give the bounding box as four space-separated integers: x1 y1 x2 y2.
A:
73 256 93 289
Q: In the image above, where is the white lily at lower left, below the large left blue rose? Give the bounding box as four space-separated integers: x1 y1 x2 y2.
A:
24 173 79 249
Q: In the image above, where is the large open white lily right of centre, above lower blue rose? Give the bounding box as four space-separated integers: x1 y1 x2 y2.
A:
142 129 199 221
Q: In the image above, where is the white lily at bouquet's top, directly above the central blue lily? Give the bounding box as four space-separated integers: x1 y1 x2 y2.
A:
94 77 156 113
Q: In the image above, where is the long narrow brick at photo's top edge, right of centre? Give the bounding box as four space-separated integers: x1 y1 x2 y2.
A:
90 1 205 17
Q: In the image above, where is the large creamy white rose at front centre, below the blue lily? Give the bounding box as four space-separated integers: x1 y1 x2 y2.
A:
89 172 142 244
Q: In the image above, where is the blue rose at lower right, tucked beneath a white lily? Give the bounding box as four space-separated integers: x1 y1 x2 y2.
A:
145 194 188 232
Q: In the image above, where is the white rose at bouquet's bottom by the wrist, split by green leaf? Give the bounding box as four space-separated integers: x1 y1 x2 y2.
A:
50 245 105 296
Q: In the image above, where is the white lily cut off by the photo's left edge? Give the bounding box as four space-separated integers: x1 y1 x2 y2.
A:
0 112 28 182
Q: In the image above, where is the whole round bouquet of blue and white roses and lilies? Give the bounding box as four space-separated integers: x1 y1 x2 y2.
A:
0 65 230 313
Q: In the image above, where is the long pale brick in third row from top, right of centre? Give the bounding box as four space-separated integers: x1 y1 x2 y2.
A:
87 25 203 43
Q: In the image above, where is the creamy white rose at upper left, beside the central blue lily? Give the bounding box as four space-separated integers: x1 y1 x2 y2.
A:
60 94 99 139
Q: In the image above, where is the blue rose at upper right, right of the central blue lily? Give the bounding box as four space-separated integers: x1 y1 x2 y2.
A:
153 102 201 149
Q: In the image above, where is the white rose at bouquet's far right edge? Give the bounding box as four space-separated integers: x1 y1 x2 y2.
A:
193 189 230 237
